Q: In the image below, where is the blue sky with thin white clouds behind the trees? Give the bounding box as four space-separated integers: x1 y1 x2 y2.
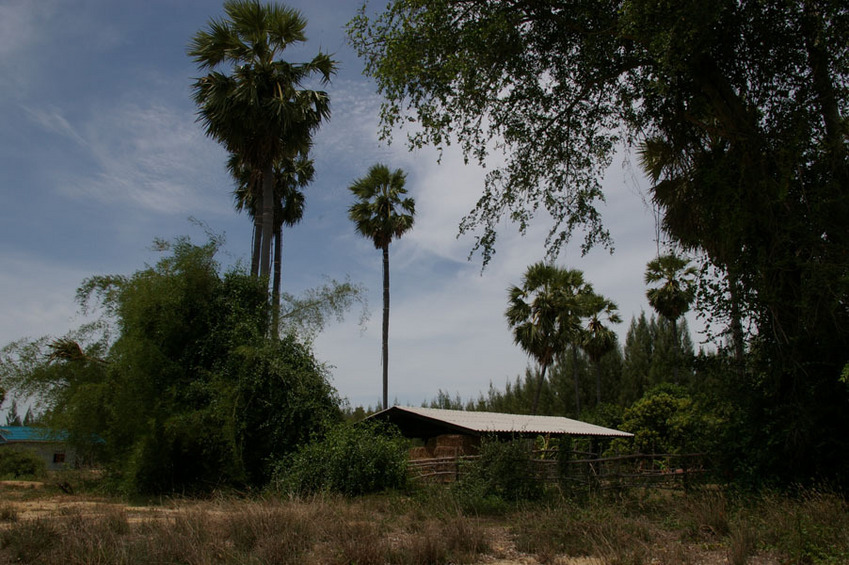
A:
0 0 698 412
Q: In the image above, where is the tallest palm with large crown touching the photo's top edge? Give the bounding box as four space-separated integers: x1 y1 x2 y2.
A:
188 0 336 277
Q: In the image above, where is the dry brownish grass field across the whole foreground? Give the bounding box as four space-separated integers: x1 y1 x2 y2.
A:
0 481 849 565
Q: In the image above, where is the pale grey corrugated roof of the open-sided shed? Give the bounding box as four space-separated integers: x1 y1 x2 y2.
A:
374 406 633 437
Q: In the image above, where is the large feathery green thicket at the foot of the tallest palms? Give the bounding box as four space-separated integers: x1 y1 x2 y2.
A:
2 239 340 493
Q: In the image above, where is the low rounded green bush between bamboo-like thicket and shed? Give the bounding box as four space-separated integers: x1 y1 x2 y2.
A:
274 422 407 496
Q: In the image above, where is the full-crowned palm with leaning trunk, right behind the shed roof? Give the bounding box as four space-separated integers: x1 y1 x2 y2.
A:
505 262 592 414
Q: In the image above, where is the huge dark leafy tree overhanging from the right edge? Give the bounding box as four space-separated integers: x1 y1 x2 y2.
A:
349 0 849 480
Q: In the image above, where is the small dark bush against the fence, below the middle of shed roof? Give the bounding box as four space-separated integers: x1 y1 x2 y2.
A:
455 439 543 506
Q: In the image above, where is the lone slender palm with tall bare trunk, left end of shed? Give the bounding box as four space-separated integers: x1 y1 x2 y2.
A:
348 164 416 408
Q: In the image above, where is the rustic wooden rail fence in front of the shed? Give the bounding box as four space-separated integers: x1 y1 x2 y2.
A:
408 451 709 490
